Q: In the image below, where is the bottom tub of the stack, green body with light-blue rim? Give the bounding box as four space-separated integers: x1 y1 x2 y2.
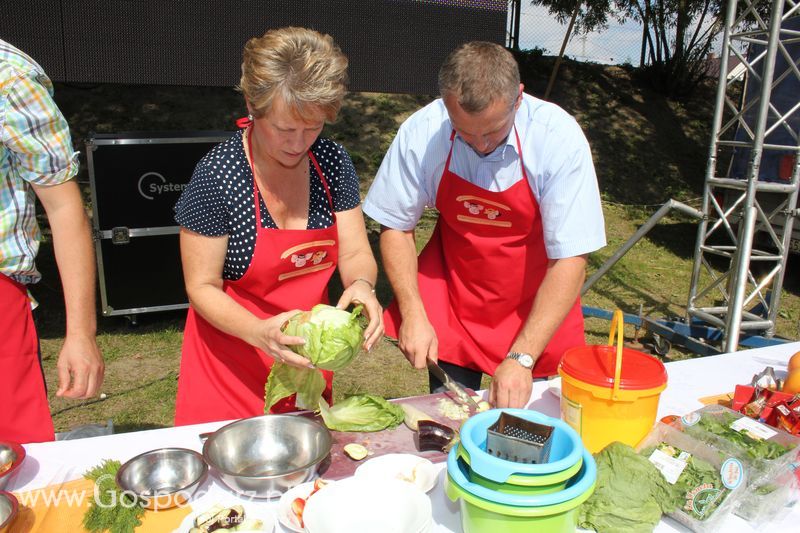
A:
445 446 597 533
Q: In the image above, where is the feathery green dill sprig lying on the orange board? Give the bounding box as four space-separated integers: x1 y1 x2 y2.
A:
83 460 144 533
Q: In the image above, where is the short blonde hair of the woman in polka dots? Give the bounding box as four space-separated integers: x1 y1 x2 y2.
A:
239 27 347 121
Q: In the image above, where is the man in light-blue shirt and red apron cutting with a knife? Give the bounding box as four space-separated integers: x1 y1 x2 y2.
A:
364 42 606 407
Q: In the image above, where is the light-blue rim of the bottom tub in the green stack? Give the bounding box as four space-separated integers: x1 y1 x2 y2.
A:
447 449 597 507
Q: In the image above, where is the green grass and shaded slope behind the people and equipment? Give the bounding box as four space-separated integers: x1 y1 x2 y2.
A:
32 58 800 431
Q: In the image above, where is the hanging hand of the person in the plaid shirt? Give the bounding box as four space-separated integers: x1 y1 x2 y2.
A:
56 335 105 399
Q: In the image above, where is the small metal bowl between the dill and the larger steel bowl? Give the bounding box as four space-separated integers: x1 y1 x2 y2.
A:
117 448 208 510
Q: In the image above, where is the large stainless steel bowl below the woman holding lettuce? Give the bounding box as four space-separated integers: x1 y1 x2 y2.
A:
203 415 331 498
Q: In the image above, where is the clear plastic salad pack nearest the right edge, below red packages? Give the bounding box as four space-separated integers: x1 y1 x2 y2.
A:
671 405 800 527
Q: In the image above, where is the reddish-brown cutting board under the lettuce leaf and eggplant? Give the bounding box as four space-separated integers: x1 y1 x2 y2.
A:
310 389 474 479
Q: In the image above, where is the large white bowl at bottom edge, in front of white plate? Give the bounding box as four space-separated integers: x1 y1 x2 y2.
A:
303 476 433 533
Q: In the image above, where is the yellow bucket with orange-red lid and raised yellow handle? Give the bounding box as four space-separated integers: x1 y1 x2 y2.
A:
558 310 667 453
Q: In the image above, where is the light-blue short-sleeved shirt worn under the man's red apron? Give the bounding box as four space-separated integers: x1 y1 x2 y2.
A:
363 94 606 259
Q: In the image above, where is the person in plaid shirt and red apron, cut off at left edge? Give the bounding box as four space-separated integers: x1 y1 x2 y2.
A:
0 40 104 443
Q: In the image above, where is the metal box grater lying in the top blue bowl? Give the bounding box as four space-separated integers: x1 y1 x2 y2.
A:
486 412 553 464
